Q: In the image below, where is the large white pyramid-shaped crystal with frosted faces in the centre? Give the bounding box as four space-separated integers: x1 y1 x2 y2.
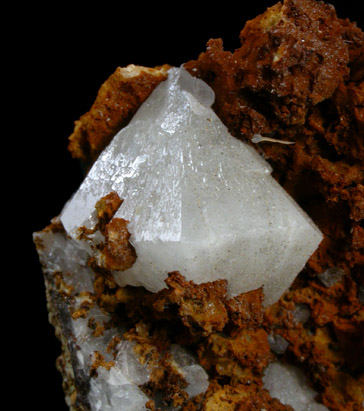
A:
61 68 322 304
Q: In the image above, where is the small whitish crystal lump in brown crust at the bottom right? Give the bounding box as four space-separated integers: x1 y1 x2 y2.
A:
263 361 328 411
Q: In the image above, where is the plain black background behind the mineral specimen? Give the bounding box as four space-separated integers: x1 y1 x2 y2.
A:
12 1 364 411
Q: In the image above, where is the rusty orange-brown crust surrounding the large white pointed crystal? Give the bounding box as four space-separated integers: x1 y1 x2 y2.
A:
58 0 364 411
